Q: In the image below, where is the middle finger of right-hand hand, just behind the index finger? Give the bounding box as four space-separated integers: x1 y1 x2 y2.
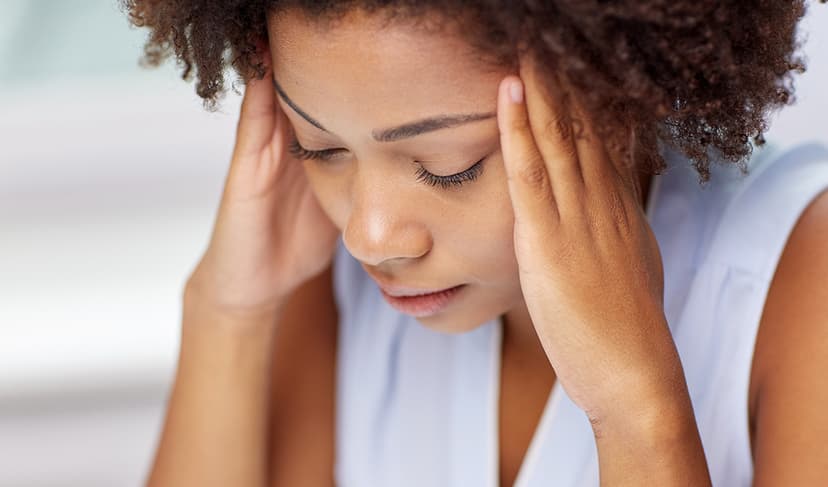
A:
520 56 584 205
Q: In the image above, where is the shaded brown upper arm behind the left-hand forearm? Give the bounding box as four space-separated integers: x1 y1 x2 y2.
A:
268 269 338 487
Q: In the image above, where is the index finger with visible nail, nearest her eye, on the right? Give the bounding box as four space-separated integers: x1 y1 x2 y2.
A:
497 76 558 226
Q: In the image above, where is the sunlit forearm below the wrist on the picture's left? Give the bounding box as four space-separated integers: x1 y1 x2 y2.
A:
148 293 279 487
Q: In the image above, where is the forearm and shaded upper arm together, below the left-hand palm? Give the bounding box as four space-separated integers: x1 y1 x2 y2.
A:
149 268 337 487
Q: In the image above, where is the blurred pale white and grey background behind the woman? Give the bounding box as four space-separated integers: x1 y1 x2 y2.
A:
0 0 828 487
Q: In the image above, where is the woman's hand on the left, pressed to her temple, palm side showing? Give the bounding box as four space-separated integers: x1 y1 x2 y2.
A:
185 48 339 315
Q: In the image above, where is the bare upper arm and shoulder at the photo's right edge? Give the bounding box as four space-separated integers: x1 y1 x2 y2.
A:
750 185 828 485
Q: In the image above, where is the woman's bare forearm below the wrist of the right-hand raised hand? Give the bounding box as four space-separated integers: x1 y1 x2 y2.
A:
593 382 710 487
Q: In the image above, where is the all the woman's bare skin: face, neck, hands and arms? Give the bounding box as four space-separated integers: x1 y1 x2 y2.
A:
148 3 828 486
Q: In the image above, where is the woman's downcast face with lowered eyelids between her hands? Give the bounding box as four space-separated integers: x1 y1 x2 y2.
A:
268 8 524 332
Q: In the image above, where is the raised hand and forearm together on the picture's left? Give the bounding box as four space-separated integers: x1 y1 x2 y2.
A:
148 44 339 487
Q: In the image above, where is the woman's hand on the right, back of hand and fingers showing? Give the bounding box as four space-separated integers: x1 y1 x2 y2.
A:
498 60 689 425
